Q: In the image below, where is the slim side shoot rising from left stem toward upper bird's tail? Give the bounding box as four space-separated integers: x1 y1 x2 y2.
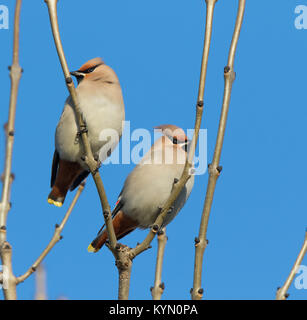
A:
17 183 84 284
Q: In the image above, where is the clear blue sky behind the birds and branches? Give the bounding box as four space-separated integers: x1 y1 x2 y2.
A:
0 0 307 299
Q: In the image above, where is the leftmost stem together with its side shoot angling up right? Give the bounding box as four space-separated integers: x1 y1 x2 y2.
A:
0 0 83 300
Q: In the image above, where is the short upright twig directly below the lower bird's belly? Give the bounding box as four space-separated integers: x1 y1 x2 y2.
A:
150 228 167 300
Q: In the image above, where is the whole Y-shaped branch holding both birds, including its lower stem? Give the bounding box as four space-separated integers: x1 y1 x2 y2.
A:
45 0 224 299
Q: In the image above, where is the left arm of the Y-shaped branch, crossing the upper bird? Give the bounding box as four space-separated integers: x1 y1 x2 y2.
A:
45 0 117 250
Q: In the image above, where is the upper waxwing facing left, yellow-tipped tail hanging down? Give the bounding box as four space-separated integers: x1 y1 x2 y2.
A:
48 58 125 207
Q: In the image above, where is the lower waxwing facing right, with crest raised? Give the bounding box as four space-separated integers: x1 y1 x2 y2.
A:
88 125 194 252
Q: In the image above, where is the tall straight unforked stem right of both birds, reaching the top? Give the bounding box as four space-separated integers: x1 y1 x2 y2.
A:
191 0 245 300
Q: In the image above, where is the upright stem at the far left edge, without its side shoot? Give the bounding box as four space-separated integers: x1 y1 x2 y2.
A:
0 0 22 300
